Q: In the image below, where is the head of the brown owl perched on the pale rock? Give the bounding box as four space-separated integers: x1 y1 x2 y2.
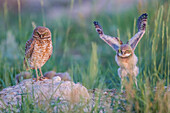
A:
32 26 51 39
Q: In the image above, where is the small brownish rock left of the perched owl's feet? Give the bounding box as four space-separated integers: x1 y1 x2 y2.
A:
15 71 32 83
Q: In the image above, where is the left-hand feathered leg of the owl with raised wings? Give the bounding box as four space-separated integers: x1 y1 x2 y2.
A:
118 68 127 92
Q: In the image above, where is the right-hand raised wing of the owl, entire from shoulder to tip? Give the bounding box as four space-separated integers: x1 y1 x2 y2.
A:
127 13 148 50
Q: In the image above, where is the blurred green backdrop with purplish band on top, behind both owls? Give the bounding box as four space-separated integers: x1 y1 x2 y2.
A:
0 0 170 89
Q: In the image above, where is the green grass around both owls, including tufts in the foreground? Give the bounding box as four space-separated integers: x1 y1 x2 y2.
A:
0 0 170 113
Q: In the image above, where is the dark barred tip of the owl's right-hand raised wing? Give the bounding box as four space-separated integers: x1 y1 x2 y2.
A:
137 13 148 31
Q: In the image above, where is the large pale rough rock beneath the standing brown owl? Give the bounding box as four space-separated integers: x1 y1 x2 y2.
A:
0 76 90 109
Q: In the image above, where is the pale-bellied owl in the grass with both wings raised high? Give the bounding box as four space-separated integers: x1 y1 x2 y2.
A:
94 13 147 90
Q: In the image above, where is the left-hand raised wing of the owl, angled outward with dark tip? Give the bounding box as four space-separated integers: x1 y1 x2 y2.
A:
93 21 123 51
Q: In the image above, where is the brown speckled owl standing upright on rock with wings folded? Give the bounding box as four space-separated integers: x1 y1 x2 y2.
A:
24 26 53 81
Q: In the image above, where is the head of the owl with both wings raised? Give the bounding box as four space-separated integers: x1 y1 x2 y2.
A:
117 44 133 58
